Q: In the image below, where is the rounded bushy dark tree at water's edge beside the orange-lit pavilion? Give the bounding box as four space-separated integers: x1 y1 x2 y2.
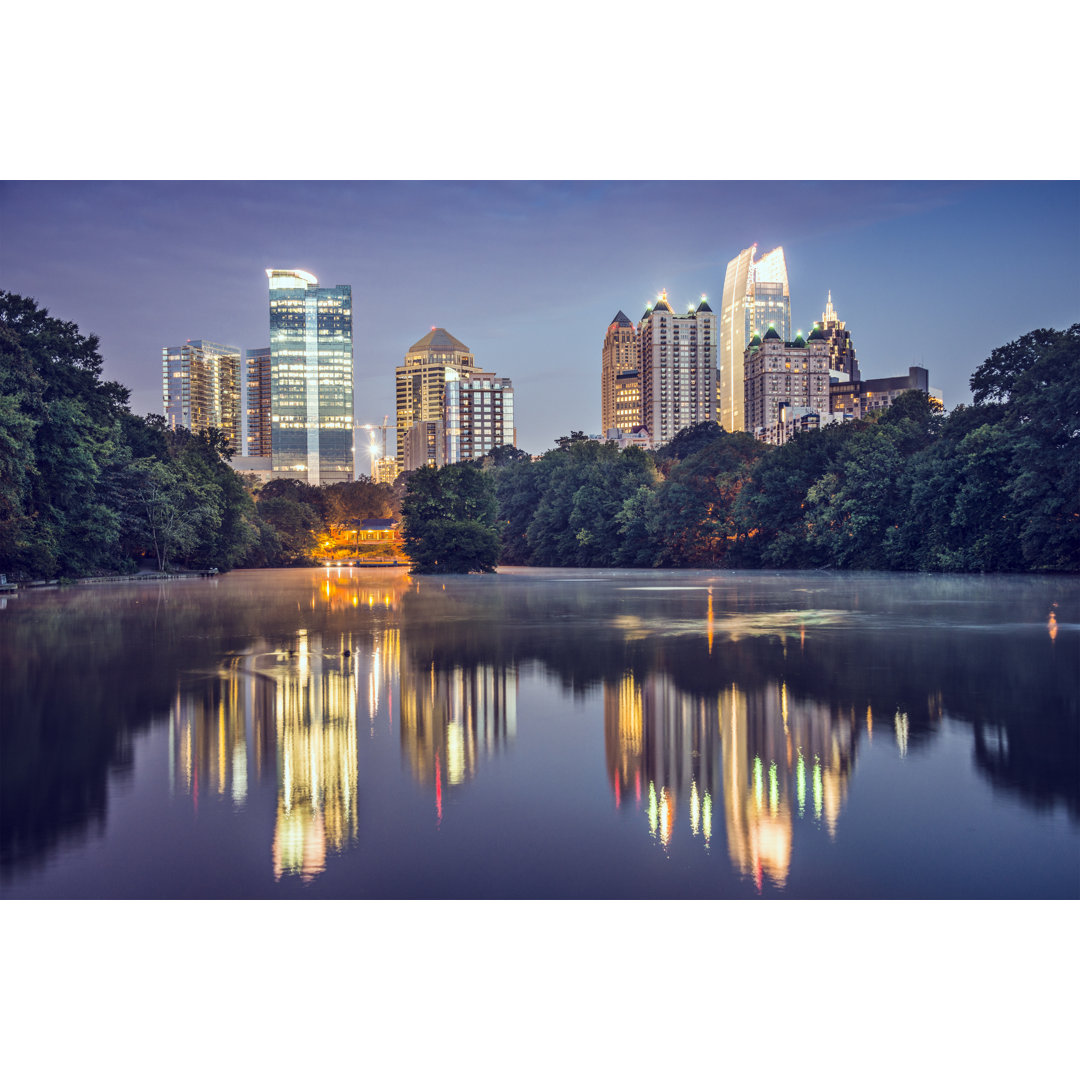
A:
402 462 499 573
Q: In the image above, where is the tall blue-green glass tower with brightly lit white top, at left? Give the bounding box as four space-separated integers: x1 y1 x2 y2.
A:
267 270 353 484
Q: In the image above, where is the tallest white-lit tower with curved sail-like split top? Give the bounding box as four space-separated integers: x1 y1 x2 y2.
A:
717 244 792 431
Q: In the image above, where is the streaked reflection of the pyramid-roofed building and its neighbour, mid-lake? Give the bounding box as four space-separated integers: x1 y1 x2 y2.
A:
400 658 517 821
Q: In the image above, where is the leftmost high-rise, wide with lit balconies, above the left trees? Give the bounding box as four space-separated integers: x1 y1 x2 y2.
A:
161 340 241 454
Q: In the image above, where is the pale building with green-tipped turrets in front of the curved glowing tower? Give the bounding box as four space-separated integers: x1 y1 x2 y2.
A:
743 327 829 441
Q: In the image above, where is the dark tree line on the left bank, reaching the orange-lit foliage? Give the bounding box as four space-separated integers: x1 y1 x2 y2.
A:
0 292 399 580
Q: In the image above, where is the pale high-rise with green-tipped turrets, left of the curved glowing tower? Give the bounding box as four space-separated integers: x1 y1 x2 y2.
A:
637 292 716 446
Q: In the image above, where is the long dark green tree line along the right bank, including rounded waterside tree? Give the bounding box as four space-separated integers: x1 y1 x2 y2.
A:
403 324 1080 572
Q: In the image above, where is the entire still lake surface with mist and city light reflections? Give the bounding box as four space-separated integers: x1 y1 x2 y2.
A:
0 568 1080 899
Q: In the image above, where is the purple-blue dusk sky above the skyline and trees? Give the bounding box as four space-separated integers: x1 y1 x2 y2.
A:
0 181 1080 457
